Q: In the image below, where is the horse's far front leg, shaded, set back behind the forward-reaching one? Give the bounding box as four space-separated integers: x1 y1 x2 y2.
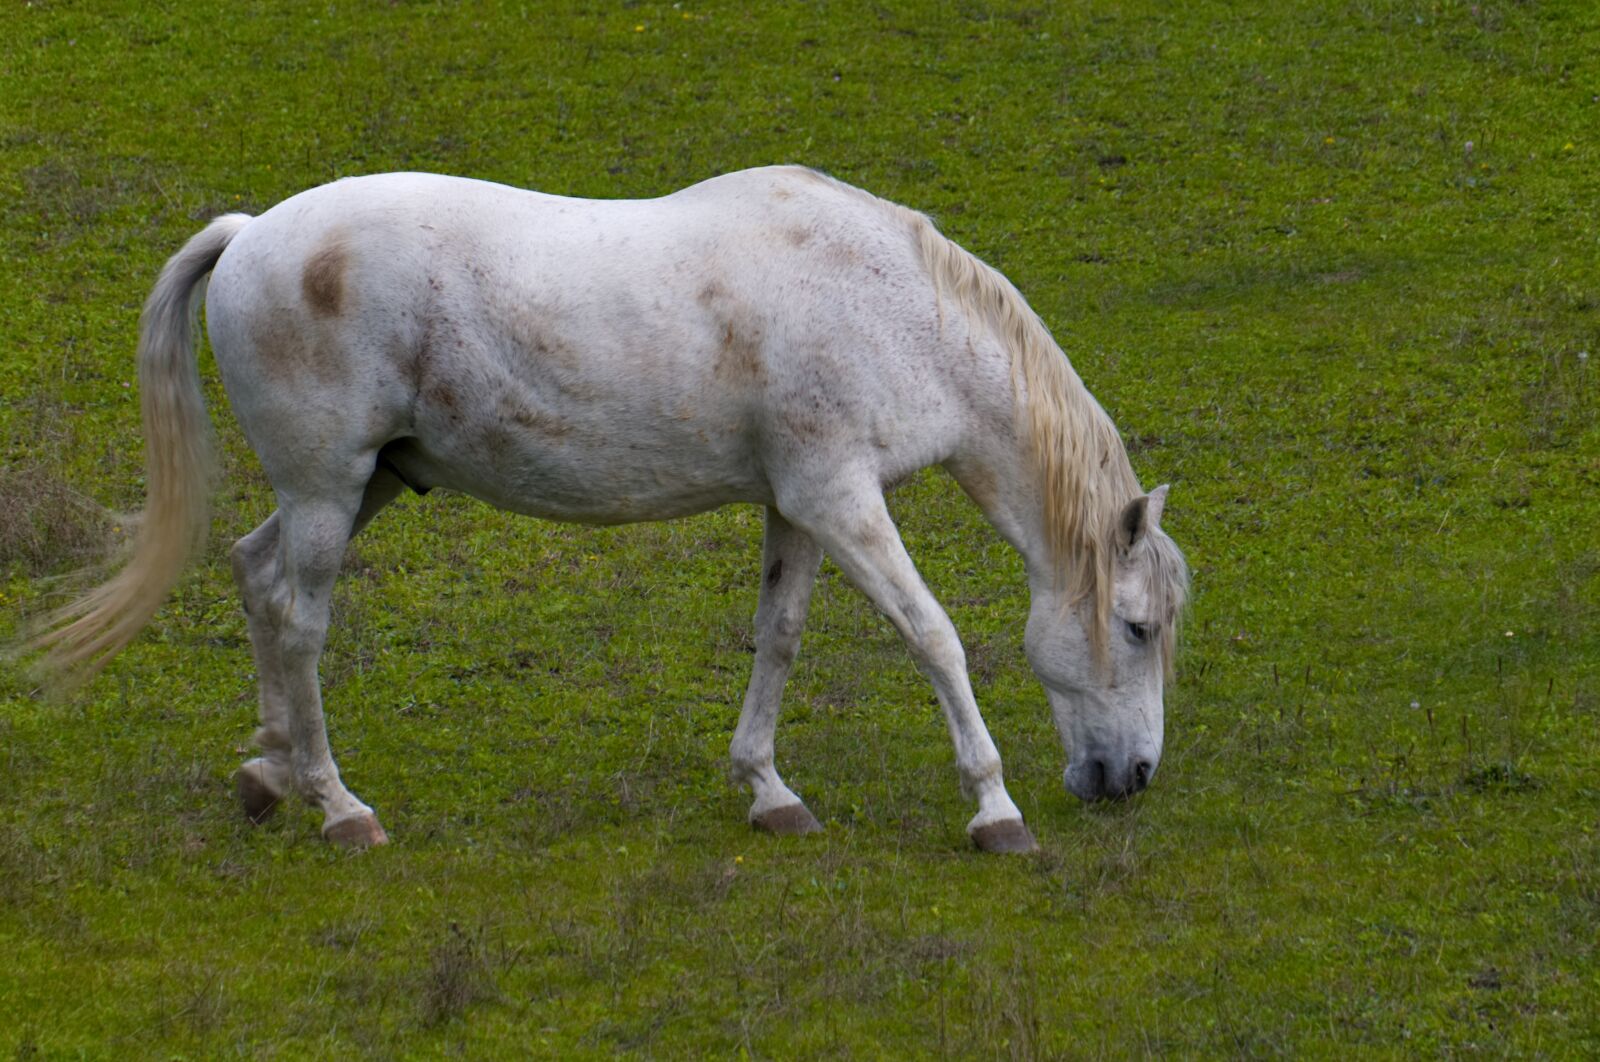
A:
731 509 822 833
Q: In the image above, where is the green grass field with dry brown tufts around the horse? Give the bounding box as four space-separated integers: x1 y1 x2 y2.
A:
0 0 1600 1059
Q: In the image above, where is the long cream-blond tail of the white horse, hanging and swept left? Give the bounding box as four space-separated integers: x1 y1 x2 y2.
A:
29 214 250 685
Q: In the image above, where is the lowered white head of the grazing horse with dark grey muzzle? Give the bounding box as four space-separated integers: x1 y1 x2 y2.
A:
1027 486 1189 800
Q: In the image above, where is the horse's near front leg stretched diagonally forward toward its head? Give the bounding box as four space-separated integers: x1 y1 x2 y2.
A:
779 472 1038 852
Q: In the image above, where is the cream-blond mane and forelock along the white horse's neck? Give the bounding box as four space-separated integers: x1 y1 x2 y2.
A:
812 167 1189 667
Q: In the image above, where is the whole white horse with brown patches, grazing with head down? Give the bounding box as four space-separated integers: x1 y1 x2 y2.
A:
37 166 1187 851
